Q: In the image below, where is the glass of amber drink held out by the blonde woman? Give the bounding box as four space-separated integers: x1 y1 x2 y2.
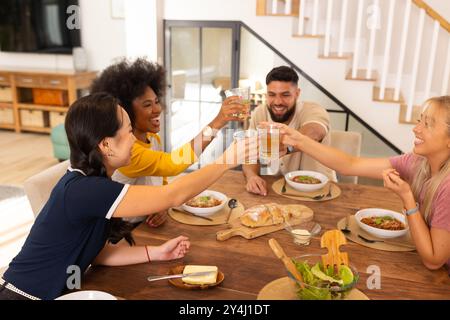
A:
257 124 280 165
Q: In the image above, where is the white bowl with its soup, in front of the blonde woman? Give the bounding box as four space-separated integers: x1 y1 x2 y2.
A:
355 208 408 239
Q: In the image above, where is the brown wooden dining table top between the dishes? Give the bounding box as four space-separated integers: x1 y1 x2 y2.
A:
82 171 450 300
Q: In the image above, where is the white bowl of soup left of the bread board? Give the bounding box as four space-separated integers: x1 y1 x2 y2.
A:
182 190 228 216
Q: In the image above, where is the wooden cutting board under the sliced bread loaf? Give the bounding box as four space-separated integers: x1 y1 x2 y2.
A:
216 205 314 241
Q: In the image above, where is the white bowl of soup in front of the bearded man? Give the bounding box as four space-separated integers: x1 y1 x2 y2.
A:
284 170 329 192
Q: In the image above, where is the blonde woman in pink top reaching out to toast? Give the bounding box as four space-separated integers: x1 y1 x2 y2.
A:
268 96 450 272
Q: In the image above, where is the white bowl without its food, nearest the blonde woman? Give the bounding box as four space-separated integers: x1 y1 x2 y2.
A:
355 208 409 239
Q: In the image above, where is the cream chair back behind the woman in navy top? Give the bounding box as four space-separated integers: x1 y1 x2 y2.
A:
24 160 70 218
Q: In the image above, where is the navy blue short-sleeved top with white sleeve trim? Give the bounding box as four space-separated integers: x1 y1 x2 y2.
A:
3 169 128 300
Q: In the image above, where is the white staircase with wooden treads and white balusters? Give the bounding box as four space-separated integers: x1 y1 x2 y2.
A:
252 0 450 152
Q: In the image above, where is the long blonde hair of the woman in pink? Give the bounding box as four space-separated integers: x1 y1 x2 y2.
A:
411 96 450 222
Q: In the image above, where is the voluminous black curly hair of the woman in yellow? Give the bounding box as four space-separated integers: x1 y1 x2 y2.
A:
90 58 166 127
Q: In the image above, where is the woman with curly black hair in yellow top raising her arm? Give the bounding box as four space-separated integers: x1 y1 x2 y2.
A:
91 58 248 227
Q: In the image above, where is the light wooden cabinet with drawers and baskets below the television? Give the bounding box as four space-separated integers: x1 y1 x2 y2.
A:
0 69 97 133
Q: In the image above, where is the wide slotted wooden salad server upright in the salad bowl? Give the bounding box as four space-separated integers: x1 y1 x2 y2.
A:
320 230 348 268
